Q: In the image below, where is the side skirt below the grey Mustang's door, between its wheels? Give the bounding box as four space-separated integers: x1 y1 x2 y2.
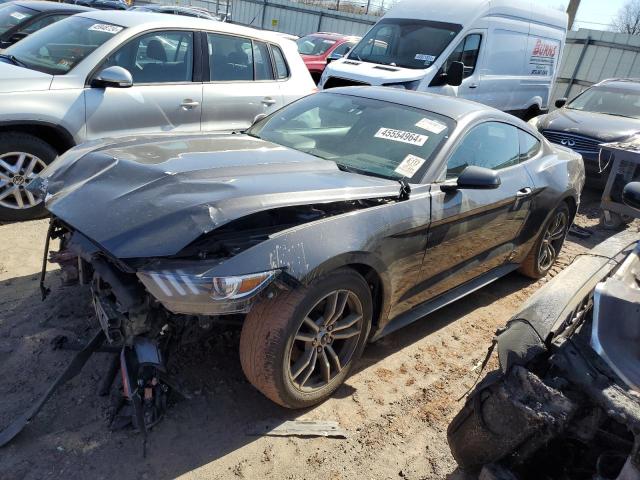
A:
370 264 519 342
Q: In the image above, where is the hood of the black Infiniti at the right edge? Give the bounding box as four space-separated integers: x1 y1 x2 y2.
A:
538 108 640 142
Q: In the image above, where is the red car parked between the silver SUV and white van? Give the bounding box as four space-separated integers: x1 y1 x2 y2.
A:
296 32 360 83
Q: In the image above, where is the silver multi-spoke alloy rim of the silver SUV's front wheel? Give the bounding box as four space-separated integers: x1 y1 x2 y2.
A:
0 152 47 210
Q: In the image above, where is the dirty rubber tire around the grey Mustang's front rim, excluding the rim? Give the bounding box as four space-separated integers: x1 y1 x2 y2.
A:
240 268 373 408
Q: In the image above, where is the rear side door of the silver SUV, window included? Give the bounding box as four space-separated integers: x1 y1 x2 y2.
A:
202 33 283 131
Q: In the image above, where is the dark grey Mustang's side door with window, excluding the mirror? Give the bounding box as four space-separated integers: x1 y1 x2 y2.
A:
408 122 534 308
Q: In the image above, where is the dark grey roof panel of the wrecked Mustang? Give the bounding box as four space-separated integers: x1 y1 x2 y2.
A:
320 86 498 121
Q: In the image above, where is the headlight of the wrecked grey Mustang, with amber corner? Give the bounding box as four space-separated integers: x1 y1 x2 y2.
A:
137 268 280 315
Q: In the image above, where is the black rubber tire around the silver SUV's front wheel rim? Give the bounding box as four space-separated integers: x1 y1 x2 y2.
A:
0 132 58 222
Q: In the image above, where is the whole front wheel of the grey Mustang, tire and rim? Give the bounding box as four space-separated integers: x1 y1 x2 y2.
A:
240 268 373 408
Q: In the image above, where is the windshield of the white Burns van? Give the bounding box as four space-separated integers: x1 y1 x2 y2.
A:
349 18 462 69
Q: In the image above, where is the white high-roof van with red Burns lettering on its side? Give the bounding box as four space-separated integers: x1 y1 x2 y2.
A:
319 0 568 118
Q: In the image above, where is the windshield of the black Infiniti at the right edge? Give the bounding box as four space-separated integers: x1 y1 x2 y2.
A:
567 87 640 118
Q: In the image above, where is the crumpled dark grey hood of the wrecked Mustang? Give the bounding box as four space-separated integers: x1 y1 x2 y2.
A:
45 135 400 258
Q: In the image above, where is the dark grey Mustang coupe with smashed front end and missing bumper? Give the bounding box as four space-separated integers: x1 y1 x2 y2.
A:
5 87 585 442
